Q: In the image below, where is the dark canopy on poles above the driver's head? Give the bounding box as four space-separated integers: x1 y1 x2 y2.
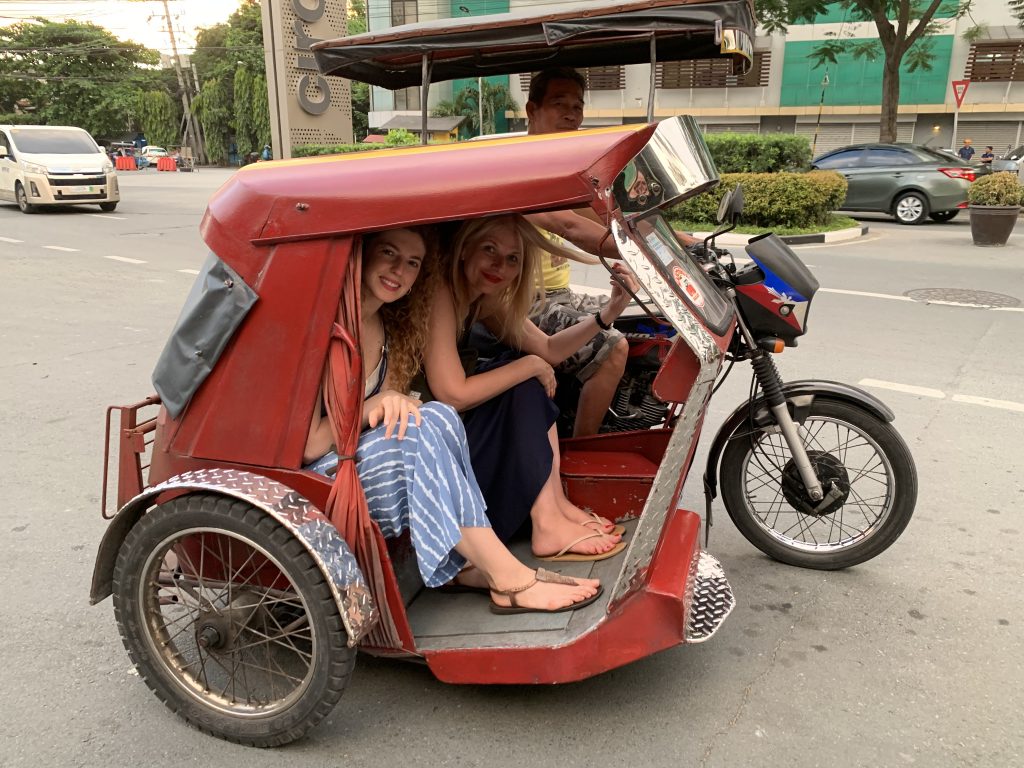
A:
311 0 756 90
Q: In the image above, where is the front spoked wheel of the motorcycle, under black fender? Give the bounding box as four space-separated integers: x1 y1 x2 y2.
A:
721 397 918 570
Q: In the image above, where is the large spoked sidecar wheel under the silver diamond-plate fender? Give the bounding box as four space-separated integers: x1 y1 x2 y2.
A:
114 495 355 746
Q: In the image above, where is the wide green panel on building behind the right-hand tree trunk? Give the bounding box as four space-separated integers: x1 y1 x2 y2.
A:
779 35 953 106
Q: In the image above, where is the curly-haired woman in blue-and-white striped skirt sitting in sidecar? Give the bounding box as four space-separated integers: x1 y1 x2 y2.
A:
303 228 600 613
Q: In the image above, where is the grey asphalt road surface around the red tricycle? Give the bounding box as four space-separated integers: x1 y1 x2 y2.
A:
0 170 1024 768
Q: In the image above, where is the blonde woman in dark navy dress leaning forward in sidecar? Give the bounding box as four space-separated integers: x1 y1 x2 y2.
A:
424 215 636 560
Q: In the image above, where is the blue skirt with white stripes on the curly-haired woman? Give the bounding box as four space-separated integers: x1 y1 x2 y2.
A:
306 402 490 587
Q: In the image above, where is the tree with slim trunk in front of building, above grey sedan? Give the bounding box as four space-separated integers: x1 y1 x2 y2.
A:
758 0 970 141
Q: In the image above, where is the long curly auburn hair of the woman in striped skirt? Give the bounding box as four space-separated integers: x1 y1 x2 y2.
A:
362 226 439 392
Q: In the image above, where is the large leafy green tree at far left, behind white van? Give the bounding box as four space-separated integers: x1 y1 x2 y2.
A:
0 18 167 137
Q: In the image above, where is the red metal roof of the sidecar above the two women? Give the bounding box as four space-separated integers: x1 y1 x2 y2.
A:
201 124 656 263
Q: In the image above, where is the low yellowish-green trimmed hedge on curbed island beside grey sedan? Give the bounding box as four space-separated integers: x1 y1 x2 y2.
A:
669 171 846 227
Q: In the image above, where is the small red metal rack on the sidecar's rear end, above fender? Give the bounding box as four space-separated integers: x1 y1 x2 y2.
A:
99 394 160 520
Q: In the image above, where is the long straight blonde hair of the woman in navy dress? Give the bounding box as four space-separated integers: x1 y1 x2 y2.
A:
447 213 597 346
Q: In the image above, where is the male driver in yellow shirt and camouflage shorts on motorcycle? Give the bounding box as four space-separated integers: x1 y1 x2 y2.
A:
526 67 696 437
